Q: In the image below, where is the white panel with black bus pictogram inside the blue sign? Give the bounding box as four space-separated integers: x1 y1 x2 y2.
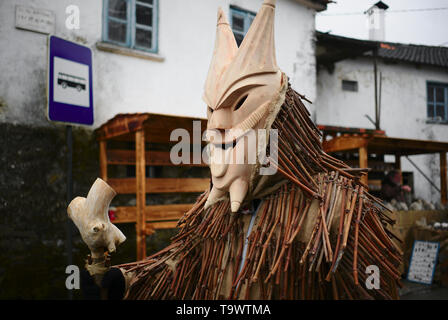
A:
53 57 90 108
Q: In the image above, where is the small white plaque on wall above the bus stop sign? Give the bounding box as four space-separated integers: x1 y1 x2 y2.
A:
16 6 55 34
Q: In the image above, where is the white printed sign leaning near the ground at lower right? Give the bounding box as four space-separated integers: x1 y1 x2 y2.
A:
408 240 439 284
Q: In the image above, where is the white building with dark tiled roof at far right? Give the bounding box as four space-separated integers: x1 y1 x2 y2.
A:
315 33 448 202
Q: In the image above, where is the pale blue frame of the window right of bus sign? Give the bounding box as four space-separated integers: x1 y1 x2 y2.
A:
102 0 159 53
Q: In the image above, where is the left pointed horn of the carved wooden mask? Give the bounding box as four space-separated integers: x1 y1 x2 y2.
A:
203 8 238 109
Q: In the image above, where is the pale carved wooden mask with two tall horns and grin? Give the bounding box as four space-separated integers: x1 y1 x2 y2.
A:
203 0 286 212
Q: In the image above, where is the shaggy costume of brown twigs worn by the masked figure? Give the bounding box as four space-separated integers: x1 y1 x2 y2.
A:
119 78 401 299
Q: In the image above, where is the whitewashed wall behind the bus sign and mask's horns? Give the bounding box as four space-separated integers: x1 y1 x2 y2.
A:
0 0 316 128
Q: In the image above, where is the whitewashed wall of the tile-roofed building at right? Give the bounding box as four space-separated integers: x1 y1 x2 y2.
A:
315 58 448 202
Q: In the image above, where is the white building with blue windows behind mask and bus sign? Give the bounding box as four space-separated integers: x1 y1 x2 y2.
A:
0 0 327 128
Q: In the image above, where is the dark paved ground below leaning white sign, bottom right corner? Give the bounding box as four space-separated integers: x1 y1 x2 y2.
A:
400 280 448 300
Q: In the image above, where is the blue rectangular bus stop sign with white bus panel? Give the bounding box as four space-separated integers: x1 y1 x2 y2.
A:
48 36 93 125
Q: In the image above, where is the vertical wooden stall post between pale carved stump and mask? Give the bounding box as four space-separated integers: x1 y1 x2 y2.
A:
136 130 146 260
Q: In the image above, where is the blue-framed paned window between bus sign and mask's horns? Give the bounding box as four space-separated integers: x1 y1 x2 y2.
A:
103 0 158 53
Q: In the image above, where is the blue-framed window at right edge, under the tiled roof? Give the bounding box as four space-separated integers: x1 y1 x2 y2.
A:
426 82 448 122
